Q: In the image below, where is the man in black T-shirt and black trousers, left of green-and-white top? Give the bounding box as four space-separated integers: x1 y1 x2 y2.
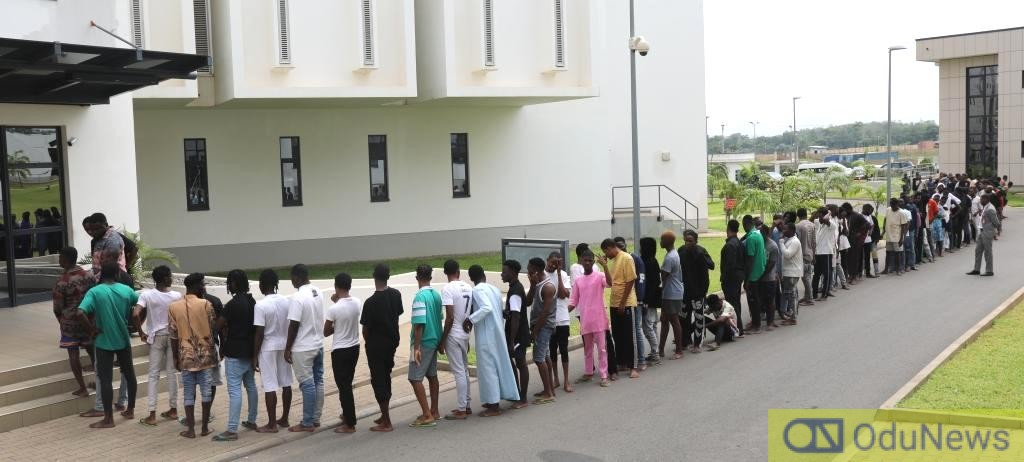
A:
359 264 403 431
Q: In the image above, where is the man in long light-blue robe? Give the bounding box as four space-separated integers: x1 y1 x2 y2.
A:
464 265 519 417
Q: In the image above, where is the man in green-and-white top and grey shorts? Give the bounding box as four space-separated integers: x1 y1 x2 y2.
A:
409 264 443 427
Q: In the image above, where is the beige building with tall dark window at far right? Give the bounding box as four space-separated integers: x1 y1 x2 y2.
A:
918 28 1024 184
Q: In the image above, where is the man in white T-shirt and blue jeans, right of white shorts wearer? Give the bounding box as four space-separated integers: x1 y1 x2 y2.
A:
285 264 324 432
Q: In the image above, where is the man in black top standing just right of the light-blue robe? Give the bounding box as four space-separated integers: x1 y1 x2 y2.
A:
502 260 532 409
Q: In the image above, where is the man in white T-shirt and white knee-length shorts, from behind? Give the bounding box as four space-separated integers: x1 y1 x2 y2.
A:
253 269 292 433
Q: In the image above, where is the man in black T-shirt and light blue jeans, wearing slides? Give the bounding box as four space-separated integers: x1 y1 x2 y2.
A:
213 269 259 442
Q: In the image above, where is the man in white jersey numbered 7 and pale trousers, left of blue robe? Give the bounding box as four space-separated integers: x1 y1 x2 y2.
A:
438 260 473 420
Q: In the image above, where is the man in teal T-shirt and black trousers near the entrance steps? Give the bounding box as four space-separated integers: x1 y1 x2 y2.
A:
78 261 138 428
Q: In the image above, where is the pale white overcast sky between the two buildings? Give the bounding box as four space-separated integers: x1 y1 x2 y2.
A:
704 0 1024 136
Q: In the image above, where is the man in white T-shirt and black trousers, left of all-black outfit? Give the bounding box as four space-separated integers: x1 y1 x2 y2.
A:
324 272 362 433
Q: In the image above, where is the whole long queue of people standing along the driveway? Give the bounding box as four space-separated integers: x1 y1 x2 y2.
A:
53 175 1008 442
